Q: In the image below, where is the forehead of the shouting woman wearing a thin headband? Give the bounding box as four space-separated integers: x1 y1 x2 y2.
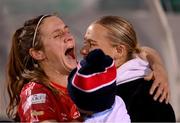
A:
40 16 65 34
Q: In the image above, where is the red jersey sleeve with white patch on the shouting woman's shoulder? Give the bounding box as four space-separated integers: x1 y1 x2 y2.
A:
18 82 58 122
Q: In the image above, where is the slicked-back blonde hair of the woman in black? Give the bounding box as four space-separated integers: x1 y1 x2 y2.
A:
93 16 140 58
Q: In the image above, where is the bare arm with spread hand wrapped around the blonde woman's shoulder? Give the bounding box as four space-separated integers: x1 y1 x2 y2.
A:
140 47 170 103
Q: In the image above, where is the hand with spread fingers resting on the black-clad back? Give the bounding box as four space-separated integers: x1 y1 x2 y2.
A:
144 65 170 104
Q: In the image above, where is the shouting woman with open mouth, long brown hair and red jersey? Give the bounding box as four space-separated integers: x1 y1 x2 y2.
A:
7 15 80 122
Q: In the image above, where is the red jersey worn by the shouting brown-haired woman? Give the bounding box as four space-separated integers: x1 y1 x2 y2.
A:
18 82 80 122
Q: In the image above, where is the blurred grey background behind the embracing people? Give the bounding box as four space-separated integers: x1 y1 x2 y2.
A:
0 0 180 121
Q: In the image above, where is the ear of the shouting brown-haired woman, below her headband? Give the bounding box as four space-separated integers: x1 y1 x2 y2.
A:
29 48 46 61
